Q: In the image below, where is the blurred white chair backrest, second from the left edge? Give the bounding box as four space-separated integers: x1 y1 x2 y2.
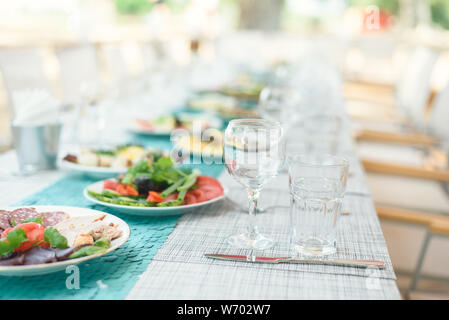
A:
56 45 101 102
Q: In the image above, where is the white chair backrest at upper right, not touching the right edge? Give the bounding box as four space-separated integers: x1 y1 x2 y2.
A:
398 47 438 127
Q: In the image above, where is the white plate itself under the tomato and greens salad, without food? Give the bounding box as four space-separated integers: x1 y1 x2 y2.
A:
84 181 228 217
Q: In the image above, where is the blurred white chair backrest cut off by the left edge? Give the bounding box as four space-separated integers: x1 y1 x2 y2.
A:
0 48 53 107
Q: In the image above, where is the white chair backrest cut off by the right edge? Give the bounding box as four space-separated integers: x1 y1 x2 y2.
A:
428 83 449 141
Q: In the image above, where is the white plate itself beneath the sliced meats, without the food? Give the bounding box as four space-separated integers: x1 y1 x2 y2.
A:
0 206 130 276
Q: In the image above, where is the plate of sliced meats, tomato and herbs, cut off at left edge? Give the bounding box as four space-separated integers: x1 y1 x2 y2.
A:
0 206 130 276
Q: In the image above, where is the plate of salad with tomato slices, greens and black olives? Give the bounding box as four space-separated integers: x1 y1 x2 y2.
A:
84 157 226 216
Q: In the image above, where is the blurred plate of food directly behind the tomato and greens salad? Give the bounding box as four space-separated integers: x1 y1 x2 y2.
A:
59 144 168 179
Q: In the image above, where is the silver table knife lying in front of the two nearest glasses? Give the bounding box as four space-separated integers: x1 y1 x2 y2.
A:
204 253 385 269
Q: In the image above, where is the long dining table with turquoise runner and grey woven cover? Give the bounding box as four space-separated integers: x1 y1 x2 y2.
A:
0 68 401 299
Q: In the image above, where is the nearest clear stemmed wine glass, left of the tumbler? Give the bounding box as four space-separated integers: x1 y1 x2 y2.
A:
223 119 285 250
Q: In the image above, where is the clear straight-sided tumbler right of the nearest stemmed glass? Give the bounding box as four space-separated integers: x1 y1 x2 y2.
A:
287 154 349 256
